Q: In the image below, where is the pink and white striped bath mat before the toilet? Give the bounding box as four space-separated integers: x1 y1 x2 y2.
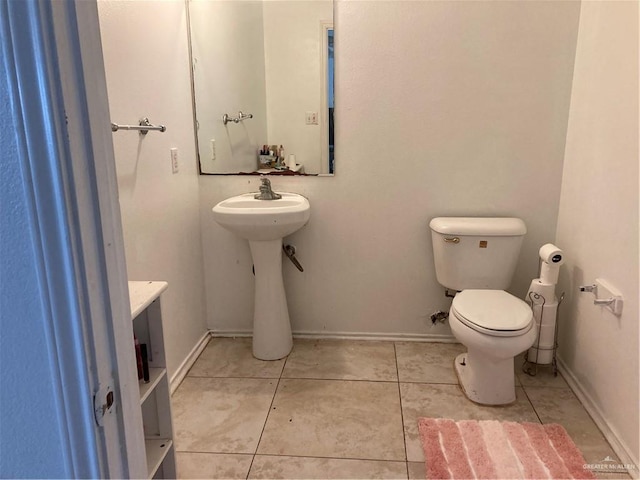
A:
418 418 596 479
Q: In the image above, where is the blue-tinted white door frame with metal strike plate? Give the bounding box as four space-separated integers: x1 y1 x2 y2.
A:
0 0 146 478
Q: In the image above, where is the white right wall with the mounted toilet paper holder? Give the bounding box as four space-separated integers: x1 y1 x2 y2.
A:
556 2 640 464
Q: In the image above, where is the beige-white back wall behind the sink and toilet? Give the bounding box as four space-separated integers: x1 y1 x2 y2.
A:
200 1 580 336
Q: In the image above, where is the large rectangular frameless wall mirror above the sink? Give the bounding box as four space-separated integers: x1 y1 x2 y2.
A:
187 0 334 175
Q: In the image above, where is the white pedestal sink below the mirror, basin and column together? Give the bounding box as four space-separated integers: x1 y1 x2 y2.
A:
213 192 311 360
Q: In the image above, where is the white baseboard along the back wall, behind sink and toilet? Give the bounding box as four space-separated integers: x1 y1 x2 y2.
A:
211 330 458 343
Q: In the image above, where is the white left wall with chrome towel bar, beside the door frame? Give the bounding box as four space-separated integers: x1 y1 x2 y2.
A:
98 0 207 382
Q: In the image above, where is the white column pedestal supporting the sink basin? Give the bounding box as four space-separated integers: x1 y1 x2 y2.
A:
249 238 293 360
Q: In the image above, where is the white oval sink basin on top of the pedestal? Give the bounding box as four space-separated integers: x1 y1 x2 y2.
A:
213 192 311 240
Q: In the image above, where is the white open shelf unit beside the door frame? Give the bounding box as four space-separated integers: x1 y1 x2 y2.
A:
129 282 176 478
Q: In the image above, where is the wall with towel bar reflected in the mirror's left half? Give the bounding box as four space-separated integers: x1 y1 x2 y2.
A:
190 0 267 173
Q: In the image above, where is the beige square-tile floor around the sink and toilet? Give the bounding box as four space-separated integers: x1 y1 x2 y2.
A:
172 338 629 479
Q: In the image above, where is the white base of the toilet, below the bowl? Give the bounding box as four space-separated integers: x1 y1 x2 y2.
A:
454 351 516 406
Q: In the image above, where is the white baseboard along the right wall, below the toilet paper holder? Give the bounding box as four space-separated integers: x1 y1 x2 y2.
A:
558 357 640 478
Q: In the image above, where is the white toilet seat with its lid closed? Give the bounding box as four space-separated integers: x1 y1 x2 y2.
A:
451 290 533 337
